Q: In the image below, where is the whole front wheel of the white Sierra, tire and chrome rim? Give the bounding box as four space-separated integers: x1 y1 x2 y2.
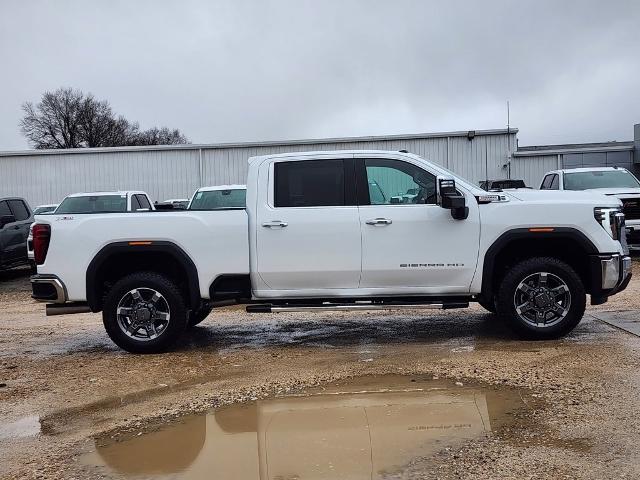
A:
496 257 586 340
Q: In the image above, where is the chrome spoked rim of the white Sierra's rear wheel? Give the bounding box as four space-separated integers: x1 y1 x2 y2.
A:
116 288 171 342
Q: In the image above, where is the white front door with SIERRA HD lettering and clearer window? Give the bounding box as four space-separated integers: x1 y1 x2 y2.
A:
356 154 480 294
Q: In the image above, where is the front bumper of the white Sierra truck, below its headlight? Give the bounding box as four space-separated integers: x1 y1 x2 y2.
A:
589 253 632 305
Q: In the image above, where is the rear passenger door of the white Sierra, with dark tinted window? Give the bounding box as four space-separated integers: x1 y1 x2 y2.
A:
255 154 361 290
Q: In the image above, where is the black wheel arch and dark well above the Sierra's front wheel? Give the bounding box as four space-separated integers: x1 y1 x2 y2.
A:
481 227 598 299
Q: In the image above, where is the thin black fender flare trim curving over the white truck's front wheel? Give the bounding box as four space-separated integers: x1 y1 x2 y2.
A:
481 227 599 299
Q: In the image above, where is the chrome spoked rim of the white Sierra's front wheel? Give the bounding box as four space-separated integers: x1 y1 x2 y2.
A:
513 272 571 328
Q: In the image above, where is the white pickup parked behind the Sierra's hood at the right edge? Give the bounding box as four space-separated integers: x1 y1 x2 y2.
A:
540 167 640 250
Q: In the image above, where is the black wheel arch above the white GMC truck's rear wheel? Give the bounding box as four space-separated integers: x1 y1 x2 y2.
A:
86 241 200 312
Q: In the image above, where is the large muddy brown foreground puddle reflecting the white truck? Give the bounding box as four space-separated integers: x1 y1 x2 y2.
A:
85 377 522 480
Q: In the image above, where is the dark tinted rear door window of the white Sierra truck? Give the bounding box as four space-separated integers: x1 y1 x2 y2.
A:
274 160 345 207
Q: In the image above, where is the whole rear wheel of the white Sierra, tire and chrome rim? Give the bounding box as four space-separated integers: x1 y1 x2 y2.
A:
102 272 187 353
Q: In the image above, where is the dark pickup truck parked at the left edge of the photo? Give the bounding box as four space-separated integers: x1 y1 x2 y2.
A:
0 197 33 270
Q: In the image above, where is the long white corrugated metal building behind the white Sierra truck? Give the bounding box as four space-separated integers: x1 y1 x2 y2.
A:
0 129 516 206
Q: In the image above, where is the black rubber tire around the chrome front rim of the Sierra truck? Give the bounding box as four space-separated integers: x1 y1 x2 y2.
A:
496 257 586 340
